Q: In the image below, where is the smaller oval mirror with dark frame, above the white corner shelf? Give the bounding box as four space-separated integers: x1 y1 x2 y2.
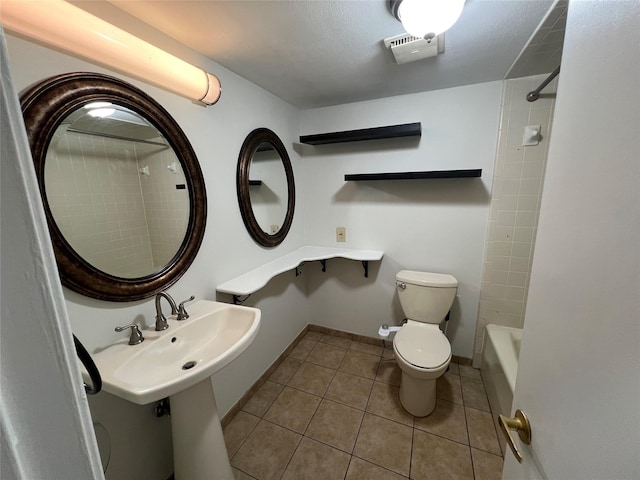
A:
236 128 295 247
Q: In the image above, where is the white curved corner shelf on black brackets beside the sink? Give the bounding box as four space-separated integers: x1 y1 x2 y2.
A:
216 246 384 303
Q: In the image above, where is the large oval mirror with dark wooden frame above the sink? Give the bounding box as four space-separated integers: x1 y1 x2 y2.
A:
21 73 206 301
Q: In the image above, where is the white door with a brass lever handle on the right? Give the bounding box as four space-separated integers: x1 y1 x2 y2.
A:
503 1 640 480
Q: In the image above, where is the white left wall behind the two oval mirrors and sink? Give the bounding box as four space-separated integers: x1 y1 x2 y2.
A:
3 28 307 480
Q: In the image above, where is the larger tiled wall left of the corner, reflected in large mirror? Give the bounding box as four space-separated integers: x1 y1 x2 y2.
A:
45 132 151 277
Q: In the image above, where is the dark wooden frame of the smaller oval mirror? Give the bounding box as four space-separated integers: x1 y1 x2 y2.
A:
236 128 296 247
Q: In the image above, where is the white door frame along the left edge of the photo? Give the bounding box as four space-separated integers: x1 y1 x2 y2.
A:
0 28 104 480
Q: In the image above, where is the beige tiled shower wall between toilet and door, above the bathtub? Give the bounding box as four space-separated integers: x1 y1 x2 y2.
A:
473 75 557 367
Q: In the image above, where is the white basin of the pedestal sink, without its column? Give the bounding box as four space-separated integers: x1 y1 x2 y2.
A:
93 300 260 405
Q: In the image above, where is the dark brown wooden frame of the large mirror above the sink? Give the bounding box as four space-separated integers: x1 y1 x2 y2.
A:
20 72 207 302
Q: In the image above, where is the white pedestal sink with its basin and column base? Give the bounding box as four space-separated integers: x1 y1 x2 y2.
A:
93 300 260 480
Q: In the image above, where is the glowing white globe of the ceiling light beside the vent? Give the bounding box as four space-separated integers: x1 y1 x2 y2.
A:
389 0 465 41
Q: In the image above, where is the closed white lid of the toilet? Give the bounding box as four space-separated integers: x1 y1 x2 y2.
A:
393 325 451 368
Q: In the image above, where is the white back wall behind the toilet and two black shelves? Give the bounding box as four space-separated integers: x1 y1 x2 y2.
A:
297 82 502 358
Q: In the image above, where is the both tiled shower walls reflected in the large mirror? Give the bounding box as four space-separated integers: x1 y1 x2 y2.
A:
45 128 188 278
